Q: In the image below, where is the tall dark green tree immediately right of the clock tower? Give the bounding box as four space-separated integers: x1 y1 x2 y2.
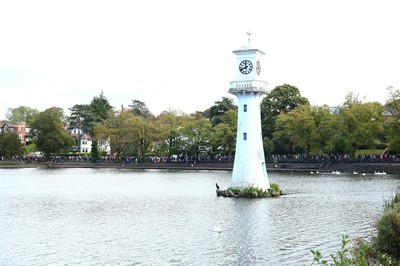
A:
261 84 310 139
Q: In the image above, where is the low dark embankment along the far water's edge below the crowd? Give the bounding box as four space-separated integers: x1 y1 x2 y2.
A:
0 161 400 174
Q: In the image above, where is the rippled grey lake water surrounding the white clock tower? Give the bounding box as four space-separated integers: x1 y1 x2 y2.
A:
0 169 400 265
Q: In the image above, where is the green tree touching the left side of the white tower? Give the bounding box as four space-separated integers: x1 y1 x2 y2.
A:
210 109 237 162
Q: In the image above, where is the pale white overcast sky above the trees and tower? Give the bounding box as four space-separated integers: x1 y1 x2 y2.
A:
0 0 400 119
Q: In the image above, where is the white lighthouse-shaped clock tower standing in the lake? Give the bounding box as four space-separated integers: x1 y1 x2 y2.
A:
229 33 270 190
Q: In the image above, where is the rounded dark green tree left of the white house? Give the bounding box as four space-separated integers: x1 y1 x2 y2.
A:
32 107 74 158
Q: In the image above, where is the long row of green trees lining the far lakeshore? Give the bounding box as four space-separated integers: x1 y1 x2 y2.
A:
0 84 400 160
